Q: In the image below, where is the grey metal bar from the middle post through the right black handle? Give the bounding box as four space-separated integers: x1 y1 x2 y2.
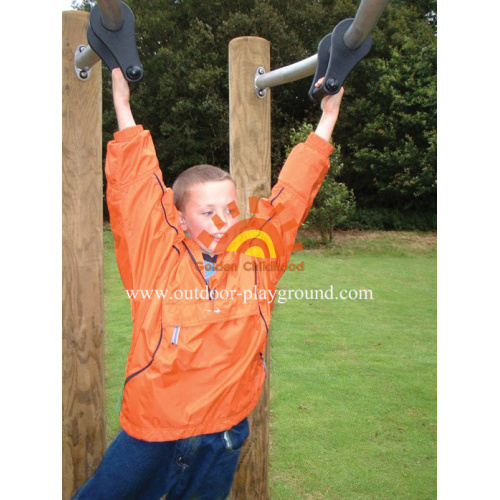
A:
254 0 390 93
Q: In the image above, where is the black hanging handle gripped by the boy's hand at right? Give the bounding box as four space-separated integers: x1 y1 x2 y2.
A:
309 19 372 103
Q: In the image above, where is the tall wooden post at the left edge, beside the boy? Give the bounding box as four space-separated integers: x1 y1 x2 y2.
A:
62 11 106 499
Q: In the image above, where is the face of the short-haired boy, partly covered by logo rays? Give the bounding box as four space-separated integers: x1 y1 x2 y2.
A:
179 179 238 255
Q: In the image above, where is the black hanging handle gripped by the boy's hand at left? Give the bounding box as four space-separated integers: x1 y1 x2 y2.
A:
87 2 144 83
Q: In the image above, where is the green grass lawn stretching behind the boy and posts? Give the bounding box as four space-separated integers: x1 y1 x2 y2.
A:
100 231 437 500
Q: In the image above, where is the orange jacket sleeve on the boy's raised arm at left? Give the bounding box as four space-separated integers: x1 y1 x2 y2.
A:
105 125 184 289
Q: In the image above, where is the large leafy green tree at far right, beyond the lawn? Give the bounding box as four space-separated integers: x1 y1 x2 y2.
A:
336 2 437 211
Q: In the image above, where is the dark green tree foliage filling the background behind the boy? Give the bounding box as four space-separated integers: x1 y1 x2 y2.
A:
75 0 437 219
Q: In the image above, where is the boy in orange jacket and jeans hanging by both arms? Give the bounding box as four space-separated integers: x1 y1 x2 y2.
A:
75 69 343 500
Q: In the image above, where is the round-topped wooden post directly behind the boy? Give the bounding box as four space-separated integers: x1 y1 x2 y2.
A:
229 37 271 500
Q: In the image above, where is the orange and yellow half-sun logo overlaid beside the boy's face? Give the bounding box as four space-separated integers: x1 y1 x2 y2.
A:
194 196 302 259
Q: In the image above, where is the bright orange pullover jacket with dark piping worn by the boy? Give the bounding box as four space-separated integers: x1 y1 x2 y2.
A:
105 125 333 441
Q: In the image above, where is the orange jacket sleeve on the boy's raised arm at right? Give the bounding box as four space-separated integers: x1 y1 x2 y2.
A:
258 133 334 283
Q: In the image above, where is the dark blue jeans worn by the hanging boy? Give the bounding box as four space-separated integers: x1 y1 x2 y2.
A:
73 418 249 500
